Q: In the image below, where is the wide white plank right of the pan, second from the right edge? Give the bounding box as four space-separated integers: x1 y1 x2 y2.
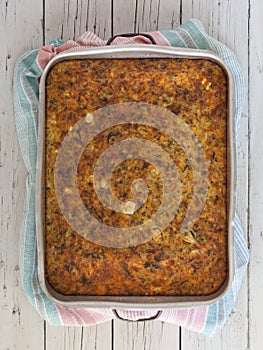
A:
182 0 249 350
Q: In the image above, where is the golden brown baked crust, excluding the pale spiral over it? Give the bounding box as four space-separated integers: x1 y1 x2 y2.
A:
45 59 227 295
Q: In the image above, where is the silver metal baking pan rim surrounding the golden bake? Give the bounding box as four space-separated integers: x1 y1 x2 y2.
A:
36 45 236 309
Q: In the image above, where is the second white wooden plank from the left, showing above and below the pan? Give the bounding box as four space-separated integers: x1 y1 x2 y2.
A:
44 0 111 350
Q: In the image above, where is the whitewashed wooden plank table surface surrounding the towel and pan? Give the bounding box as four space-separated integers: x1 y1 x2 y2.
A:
0 0 263 350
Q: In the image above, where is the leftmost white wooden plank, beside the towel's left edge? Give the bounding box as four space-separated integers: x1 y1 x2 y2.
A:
0 0 44 350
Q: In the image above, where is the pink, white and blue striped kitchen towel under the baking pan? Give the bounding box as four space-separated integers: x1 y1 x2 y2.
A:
14 19 248 336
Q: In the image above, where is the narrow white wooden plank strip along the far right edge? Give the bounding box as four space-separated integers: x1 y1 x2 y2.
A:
249 0 263 350
